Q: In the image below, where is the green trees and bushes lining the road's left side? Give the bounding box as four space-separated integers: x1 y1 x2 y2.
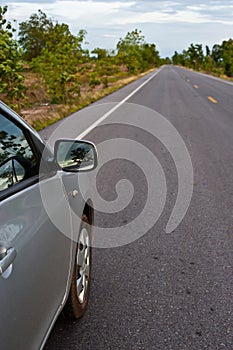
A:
0 6 162 104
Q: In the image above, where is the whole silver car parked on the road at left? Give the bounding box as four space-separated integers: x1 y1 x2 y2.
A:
0 102 97 350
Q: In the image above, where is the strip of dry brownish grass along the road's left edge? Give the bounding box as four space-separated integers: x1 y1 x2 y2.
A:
21 69 154 131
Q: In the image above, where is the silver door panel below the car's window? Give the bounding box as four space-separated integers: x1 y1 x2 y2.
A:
0 174 72 349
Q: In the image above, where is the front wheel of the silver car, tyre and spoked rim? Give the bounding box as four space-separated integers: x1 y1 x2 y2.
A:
67 215 92 319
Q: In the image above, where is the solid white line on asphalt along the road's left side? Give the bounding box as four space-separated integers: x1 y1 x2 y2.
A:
76 66 163 140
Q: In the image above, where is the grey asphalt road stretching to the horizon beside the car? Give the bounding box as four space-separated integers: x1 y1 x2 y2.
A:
43 66 233 350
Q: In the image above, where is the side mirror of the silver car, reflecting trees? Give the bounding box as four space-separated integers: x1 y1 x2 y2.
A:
54 139 97 172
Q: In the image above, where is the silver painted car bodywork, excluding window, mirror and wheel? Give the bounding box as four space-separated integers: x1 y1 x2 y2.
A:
0 102 95 350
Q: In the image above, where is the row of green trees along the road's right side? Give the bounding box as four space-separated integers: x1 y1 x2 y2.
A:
172 39 233 77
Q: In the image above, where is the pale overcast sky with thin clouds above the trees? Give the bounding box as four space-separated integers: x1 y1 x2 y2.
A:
3 0 233 57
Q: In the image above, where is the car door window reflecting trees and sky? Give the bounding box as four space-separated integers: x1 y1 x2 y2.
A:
0 113 38 191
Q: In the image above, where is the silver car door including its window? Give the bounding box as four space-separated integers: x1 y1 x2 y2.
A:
0 108 72 350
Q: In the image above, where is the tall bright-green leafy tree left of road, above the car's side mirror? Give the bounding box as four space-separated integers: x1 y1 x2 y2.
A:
31 23 86 103
